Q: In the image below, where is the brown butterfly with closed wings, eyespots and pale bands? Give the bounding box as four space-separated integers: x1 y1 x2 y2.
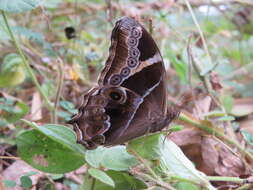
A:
69 17 180 149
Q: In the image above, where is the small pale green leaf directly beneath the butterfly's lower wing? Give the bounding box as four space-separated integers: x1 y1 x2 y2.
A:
101 146 137 171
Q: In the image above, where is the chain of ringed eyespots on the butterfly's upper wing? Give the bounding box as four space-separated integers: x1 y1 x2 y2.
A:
110 26 142 86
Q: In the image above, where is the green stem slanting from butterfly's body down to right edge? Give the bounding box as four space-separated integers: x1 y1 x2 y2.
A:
179 113 253 161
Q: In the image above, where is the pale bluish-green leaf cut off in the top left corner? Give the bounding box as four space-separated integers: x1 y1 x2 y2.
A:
0 0 39 13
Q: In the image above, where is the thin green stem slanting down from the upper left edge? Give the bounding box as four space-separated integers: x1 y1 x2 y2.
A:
1 11 54 111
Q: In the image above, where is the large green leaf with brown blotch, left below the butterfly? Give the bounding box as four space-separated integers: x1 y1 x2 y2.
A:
16 121 85 173
